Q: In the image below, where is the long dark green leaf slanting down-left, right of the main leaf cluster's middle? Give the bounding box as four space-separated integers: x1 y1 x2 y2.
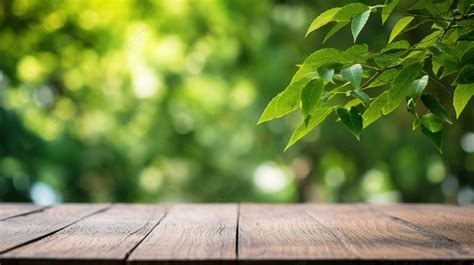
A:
382 63 422 115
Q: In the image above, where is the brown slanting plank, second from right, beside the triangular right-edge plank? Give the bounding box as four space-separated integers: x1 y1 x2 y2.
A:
306 204 474 261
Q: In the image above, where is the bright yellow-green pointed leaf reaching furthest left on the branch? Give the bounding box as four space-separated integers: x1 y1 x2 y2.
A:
257 78 309 124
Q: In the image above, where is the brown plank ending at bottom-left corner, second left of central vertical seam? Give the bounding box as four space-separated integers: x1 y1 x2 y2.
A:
0 204 165 264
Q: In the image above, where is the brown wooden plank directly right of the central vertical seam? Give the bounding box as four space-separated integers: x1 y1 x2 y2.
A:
238 204 356 264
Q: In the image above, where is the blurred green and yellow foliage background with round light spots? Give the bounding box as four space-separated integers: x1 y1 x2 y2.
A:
0 0 474 204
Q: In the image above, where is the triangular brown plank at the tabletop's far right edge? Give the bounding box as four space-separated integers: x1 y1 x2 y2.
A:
374 204 474 254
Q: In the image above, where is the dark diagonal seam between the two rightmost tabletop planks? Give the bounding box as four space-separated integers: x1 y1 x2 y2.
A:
366 206 470 255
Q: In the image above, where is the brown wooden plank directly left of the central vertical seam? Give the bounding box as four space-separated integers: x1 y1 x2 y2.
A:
128 204 238 264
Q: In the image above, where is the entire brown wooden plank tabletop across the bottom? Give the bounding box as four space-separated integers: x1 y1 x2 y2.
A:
0 204 474 265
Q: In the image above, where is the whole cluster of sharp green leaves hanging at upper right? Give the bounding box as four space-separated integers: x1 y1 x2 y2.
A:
258 0 474 151
